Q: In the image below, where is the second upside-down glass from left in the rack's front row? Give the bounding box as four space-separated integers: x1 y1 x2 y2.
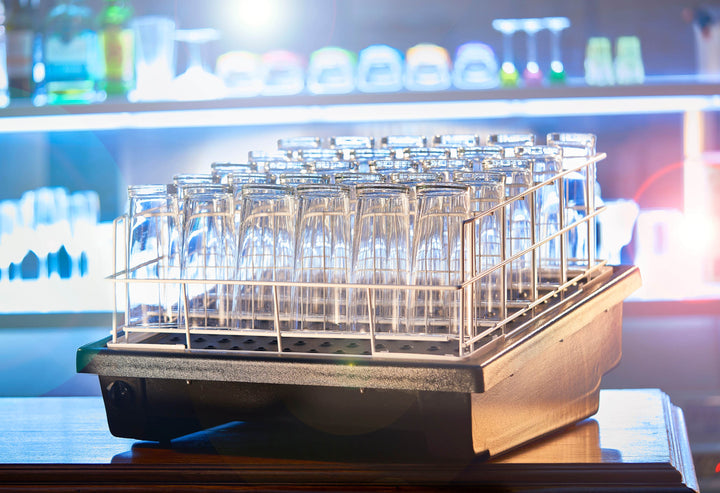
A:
179 185 235 328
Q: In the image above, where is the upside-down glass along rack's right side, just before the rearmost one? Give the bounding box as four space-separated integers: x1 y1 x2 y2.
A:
515 146 562 289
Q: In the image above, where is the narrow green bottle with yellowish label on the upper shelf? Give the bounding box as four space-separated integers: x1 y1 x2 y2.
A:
98 0 135 95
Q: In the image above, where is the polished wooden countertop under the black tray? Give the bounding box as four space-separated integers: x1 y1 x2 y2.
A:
0 389 698 492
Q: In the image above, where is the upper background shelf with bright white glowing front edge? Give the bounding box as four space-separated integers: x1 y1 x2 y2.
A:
0 76 720 133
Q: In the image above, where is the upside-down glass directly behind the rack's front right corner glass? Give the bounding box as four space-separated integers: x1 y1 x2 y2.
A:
455 171 505 337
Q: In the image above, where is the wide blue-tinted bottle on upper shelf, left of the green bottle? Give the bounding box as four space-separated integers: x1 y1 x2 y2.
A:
33 0 105 105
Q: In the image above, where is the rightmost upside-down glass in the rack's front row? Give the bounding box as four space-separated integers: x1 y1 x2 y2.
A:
408 183 470 337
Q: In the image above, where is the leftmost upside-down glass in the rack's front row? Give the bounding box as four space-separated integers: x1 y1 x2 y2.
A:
127 185 180 326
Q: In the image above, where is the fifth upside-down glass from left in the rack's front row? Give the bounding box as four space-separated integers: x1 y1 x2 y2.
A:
350 184 411 333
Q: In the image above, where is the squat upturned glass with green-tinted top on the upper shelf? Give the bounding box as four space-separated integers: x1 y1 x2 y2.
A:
307 46 357 94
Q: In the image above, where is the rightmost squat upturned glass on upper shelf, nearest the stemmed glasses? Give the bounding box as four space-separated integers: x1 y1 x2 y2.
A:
452 42 500 89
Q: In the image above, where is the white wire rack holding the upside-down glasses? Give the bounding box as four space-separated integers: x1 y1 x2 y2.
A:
107 153 606 361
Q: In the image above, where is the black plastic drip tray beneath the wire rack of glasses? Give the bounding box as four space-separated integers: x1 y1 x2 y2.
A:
77 267 640 458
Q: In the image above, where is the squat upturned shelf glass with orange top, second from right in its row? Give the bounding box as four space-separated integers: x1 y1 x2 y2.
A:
405 43 451 91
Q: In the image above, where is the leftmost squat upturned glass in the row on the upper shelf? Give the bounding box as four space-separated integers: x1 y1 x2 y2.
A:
215 51 263 97
